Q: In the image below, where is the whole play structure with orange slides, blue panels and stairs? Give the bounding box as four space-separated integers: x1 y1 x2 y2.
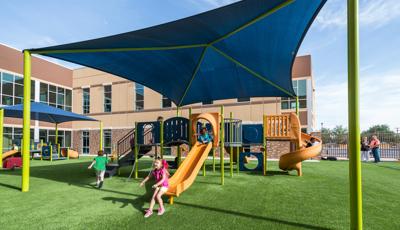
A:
106 107 321 203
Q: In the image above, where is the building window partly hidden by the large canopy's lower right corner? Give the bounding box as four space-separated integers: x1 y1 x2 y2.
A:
281 80 307 109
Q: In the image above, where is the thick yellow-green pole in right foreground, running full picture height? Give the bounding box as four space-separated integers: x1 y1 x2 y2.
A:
347 0 362 229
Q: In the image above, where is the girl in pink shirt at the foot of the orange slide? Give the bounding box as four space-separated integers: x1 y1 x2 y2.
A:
140 159 170 218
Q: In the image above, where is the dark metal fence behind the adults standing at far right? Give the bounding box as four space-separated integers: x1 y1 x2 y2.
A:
321 133 400 159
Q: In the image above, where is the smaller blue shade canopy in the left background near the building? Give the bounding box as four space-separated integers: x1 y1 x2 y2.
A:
1 102 97 124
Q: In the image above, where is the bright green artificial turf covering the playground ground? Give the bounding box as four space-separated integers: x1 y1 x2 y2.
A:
0 159 400 229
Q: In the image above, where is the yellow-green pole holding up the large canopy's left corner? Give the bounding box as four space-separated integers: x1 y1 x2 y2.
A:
21 50 31 192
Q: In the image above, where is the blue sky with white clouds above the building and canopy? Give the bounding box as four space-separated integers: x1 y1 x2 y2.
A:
0 0 400 129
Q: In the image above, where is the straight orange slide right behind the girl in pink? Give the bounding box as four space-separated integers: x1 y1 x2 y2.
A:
166 143 212 196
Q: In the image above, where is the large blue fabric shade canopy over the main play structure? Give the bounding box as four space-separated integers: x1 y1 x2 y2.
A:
30 0 326 106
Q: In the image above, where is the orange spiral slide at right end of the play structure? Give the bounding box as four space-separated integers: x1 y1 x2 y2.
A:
279 133 322 176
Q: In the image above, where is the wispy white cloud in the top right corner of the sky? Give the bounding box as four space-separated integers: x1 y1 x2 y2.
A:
316 0 400 29
